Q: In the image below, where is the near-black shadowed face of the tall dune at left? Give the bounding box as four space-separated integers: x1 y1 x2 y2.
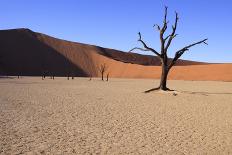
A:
0 29 87 76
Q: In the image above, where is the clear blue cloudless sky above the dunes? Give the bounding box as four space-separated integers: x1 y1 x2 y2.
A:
0 0 232 62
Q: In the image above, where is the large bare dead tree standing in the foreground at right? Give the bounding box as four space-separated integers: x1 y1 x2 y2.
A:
130 7 208 92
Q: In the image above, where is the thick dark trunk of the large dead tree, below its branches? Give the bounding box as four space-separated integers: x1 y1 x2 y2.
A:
159 61 169 91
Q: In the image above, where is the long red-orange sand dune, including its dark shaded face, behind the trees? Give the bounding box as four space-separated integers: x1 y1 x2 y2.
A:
0 29 232 81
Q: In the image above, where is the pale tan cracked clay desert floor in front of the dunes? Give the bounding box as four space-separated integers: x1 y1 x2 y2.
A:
0 77 232 154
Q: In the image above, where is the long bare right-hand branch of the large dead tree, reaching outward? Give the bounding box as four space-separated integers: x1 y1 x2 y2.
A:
168 39 208 69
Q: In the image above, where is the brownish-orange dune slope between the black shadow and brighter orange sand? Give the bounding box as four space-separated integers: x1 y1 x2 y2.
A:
36 33 98 76
